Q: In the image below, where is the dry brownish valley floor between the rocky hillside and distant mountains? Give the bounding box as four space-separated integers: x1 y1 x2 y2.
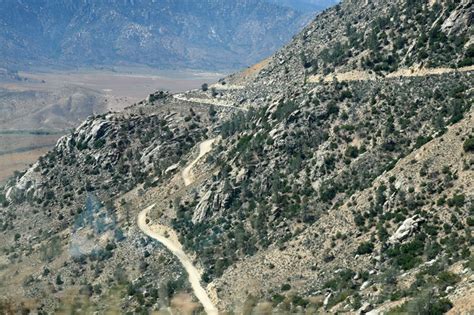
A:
0 67 224 183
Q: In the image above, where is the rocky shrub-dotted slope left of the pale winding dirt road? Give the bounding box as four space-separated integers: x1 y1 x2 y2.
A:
0 93 230 311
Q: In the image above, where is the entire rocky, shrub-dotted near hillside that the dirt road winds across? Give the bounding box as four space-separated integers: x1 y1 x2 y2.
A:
0 0 474 314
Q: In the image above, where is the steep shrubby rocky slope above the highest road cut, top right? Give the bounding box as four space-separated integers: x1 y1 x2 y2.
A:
228 0 474 89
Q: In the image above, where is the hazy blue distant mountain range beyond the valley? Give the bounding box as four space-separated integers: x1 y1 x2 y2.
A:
0 0 329 69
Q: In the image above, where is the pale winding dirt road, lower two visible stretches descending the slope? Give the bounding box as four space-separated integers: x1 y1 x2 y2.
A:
137 138 219 315
